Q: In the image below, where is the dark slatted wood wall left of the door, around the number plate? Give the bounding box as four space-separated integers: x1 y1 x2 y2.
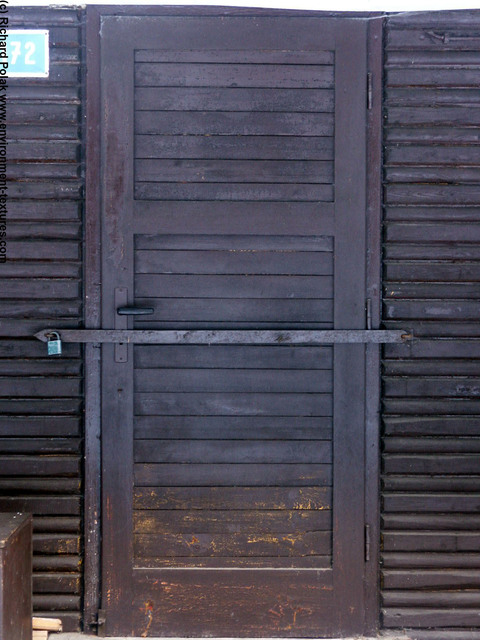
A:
0 8 83 637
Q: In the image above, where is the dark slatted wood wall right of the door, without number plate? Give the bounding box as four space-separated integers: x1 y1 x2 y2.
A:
382 12 480 640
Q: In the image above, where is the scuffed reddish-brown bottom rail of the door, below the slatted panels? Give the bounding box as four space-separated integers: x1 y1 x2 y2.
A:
134 569 338 637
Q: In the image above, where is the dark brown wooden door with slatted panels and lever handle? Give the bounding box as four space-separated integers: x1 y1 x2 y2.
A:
96 14 366 637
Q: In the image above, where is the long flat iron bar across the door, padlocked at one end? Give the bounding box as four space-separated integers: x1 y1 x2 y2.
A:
35 329 413 344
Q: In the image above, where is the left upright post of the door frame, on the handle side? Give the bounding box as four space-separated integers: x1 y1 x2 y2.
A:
83 6 101 631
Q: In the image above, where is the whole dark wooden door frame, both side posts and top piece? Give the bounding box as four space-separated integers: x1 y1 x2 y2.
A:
83 5 384 635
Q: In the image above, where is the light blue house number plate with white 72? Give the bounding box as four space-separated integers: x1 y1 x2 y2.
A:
7 29 49 78
